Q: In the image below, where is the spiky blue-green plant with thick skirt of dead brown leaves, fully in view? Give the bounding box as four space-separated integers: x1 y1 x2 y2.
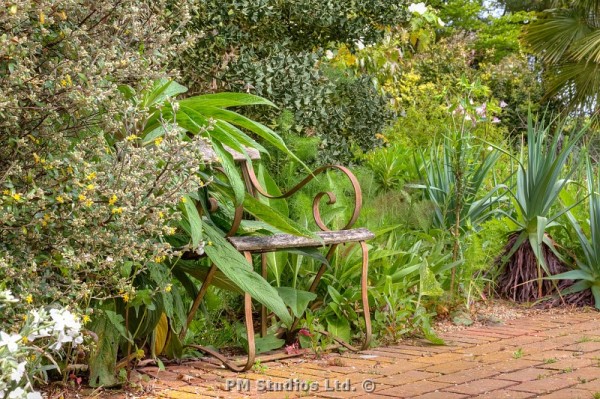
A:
497 114 587 302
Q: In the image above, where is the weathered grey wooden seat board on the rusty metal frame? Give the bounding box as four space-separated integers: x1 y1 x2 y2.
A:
228 228 375 253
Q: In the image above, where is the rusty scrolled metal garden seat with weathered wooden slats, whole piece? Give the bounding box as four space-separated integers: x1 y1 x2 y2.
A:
188 148 374 371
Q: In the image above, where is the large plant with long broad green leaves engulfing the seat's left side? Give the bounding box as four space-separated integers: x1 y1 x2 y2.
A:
90 80 310 385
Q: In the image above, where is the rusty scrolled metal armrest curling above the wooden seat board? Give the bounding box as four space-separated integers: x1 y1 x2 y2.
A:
242 162 362 231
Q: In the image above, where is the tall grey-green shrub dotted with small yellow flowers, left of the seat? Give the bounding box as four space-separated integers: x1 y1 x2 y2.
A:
0 0 198 326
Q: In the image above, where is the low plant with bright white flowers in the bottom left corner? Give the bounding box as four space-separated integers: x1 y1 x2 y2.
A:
0 291 83 399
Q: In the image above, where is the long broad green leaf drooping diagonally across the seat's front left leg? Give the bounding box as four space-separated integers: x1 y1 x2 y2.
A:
204 225 292 325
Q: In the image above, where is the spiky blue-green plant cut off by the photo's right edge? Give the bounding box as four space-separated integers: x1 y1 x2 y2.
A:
549 158 600 309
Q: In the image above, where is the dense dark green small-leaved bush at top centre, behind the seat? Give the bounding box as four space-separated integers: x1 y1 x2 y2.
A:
177 0 406 163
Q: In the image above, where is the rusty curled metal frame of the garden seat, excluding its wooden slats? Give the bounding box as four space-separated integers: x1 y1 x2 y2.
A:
181 154 372 372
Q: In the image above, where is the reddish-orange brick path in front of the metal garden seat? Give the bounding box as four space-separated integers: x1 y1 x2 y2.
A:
118 310 600 399
